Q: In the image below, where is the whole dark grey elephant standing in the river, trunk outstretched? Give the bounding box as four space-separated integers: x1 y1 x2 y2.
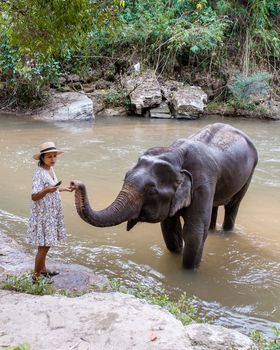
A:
71 123 258 268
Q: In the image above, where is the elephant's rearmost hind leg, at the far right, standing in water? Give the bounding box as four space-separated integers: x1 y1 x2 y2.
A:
223 177 251 231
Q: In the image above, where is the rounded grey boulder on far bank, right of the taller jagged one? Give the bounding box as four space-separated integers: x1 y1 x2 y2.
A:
170 86 207 119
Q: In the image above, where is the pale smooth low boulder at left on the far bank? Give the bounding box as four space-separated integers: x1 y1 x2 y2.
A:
32 92 94 121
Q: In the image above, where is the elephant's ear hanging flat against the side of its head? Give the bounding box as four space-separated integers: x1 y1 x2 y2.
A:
169 170 193 216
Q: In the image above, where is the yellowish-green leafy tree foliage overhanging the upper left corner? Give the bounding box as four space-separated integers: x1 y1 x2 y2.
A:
0 0 124 108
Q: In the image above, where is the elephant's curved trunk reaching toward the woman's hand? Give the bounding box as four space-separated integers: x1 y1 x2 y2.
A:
71 180 143 227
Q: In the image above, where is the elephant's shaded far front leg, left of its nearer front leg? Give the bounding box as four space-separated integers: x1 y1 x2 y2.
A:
160 215 183 253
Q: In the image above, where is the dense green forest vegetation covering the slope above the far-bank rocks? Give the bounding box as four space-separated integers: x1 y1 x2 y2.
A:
0 0 280 108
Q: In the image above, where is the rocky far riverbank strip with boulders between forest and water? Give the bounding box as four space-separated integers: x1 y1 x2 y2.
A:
0 69 280 121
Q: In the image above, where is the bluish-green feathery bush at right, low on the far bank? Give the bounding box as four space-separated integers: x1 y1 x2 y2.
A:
228 72 272 109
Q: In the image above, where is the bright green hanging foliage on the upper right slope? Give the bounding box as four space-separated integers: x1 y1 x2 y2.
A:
103 0 280 73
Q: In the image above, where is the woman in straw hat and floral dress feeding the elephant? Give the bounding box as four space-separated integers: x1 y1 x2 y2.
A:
27 142 73 281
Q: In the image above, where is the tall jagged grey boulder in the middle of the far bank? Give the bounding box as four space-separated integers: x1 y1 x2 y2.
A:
123 71 162 115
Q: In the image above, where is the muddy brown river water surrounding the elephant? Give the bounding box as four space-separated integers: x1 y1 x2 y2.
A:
0 115 280 335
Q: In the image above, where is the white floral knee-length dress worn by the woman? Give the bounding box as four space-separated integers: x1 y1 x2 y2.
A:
27 166 66 247
